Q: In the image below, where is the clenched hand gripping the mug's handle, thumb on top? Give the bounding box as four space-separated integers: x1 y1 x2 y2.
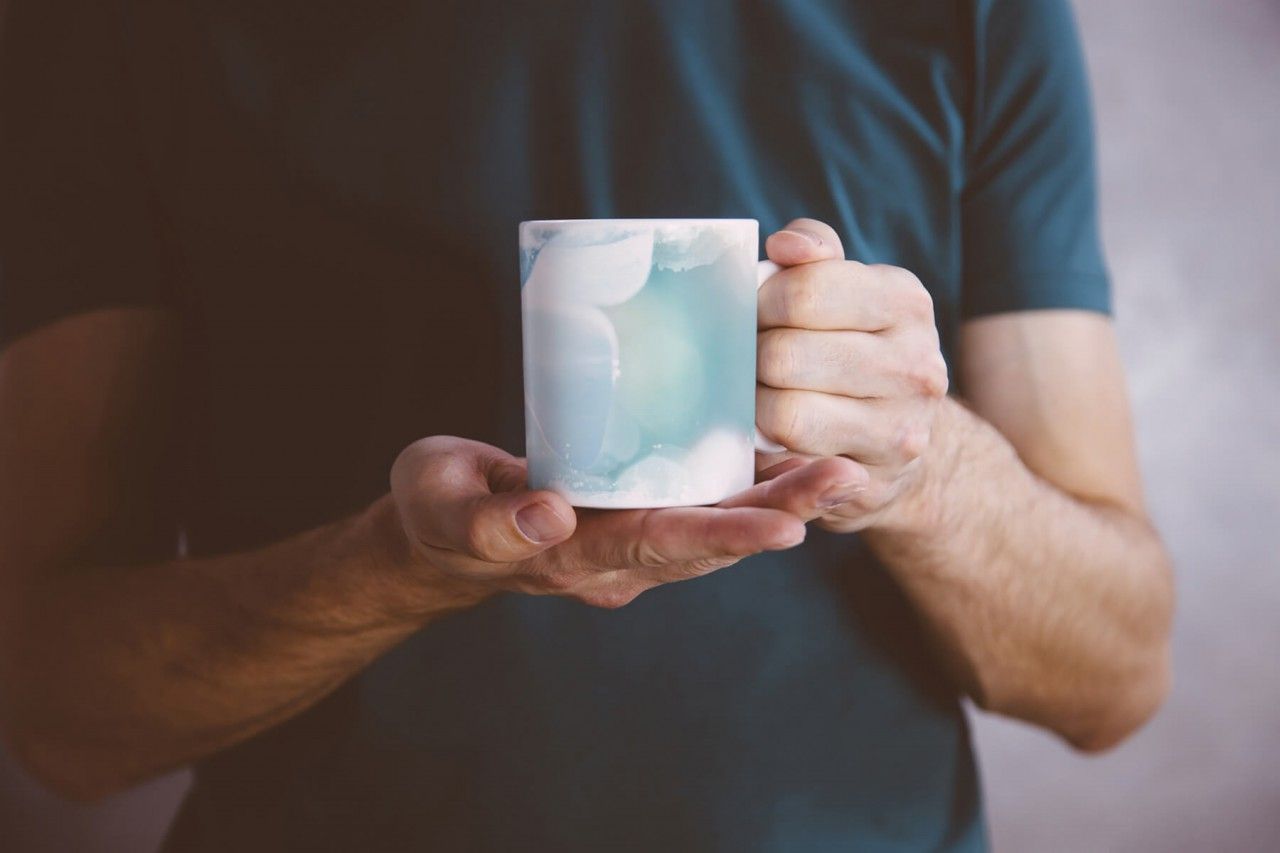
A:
756 219 947 533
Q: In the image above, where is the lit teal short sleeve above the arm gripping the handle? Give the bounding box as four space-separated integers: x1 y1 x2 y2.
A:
960 0 1111 318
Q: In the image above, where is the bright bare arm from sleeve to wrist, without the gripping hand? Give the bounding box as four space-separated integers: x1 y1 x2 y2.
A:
868 320 1174 752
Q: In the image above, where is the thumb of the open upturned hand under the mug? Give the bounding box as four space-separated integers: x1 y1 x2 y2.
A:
392 437 577 564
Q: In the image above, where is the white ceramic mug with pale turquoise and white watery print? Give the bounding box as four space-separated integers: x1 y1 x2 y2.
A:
520 219 782 508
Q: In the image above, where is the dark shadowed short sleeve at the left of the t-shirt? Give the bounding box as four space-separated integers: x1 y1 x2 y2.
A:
0 0 169 346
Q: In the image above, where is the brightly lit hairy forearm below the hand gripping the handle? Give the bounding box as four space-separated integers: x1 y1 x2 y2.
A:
867 400 1172 748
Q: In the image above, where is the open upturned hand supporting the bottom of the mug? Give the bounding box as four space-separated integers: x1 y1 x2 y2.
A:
392 435 867 608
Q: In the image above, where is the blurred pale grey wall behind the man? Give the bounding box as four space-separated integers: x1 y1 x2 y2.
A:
0 0 1280 853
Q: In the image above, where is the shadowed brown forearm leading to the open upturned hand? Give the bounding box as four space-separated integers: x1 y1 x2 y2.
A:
0 491 477 795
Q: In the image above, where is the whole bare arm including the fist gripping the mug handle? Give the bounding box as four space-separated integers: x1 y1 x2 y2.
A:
758 219 1174 751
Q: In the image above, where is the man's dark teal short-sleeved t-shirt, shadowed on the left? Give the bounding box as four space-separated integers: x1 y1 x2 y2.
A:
0 0 1108 853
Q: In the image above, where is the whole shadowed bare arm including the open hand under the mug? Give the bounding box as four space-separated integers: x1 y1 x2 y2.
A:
0 309 856 798
